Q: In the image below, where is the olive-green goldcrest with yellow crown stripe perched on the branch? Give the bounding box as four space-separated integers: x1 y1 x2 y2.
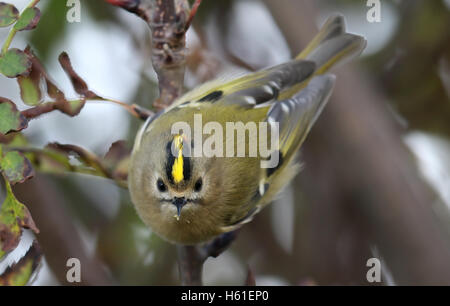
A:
128 15 366 245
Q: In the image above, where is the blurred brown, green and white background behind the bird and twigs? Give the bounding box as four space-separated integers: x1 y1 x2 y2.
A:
0 0 450 285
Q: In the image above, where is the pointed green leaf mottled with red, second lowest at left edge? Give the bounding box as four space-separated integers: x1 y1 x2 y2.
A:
0 180 39 258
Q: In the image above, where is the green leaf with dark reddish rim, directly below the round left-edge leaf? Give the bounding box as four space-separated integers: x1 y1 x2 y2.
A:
0 97 28 134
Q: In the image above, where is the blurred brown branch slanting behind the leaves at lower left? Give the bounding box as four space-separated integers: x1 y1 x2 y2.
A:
14 175 114 285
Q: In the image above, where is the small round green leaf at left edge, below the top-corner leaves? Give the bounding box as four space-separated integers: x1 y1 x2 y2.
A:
0 49 31 78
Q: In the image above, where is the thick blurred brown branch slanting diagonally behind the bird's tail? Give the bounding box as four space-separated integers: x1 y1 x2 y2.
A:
265 0 450 285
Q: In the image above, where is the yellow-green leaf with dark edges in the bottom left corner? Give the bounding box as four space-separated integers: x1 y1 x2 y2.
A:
0 240 42 286
